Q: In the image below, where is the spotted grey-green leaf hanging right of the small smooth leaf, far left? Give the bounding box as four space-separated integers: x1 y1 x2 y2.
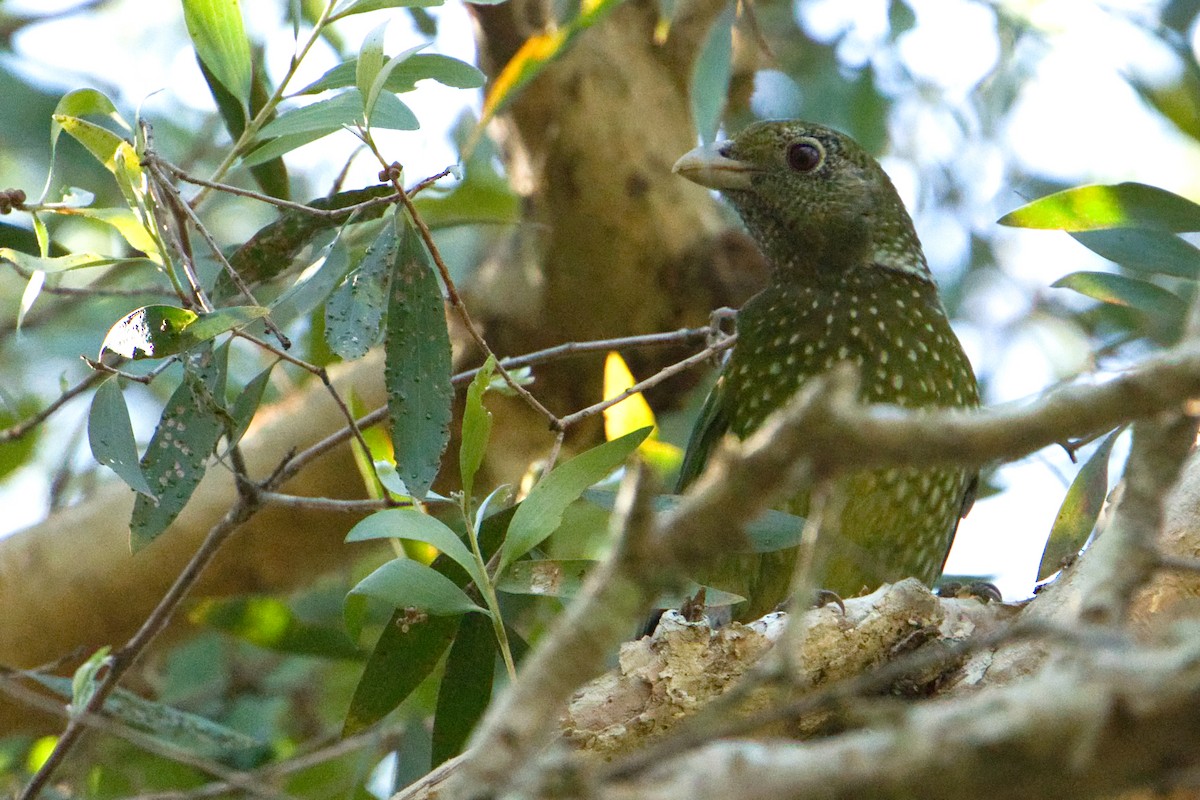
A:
130 345 227 552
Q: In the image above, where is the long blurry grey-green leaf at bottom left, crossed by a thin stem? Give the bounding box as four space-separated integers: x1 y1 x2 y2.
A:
24 673 271 769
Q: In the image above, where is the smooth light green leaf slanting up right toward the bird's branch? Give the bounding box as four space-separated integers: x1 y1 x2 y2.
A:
497 426 654 575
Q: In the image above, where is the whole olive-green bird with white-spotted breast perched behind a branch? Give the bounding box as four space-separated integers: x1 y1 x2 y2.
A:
676 121 979 619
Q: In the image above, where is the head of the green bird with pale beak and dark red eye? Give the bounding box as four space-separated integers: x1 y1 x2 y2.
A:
674 121 930 281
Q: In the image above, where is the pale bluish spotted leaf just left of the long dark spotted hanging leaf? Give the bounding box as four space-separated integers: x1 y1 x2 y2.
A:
325 219 400 361
